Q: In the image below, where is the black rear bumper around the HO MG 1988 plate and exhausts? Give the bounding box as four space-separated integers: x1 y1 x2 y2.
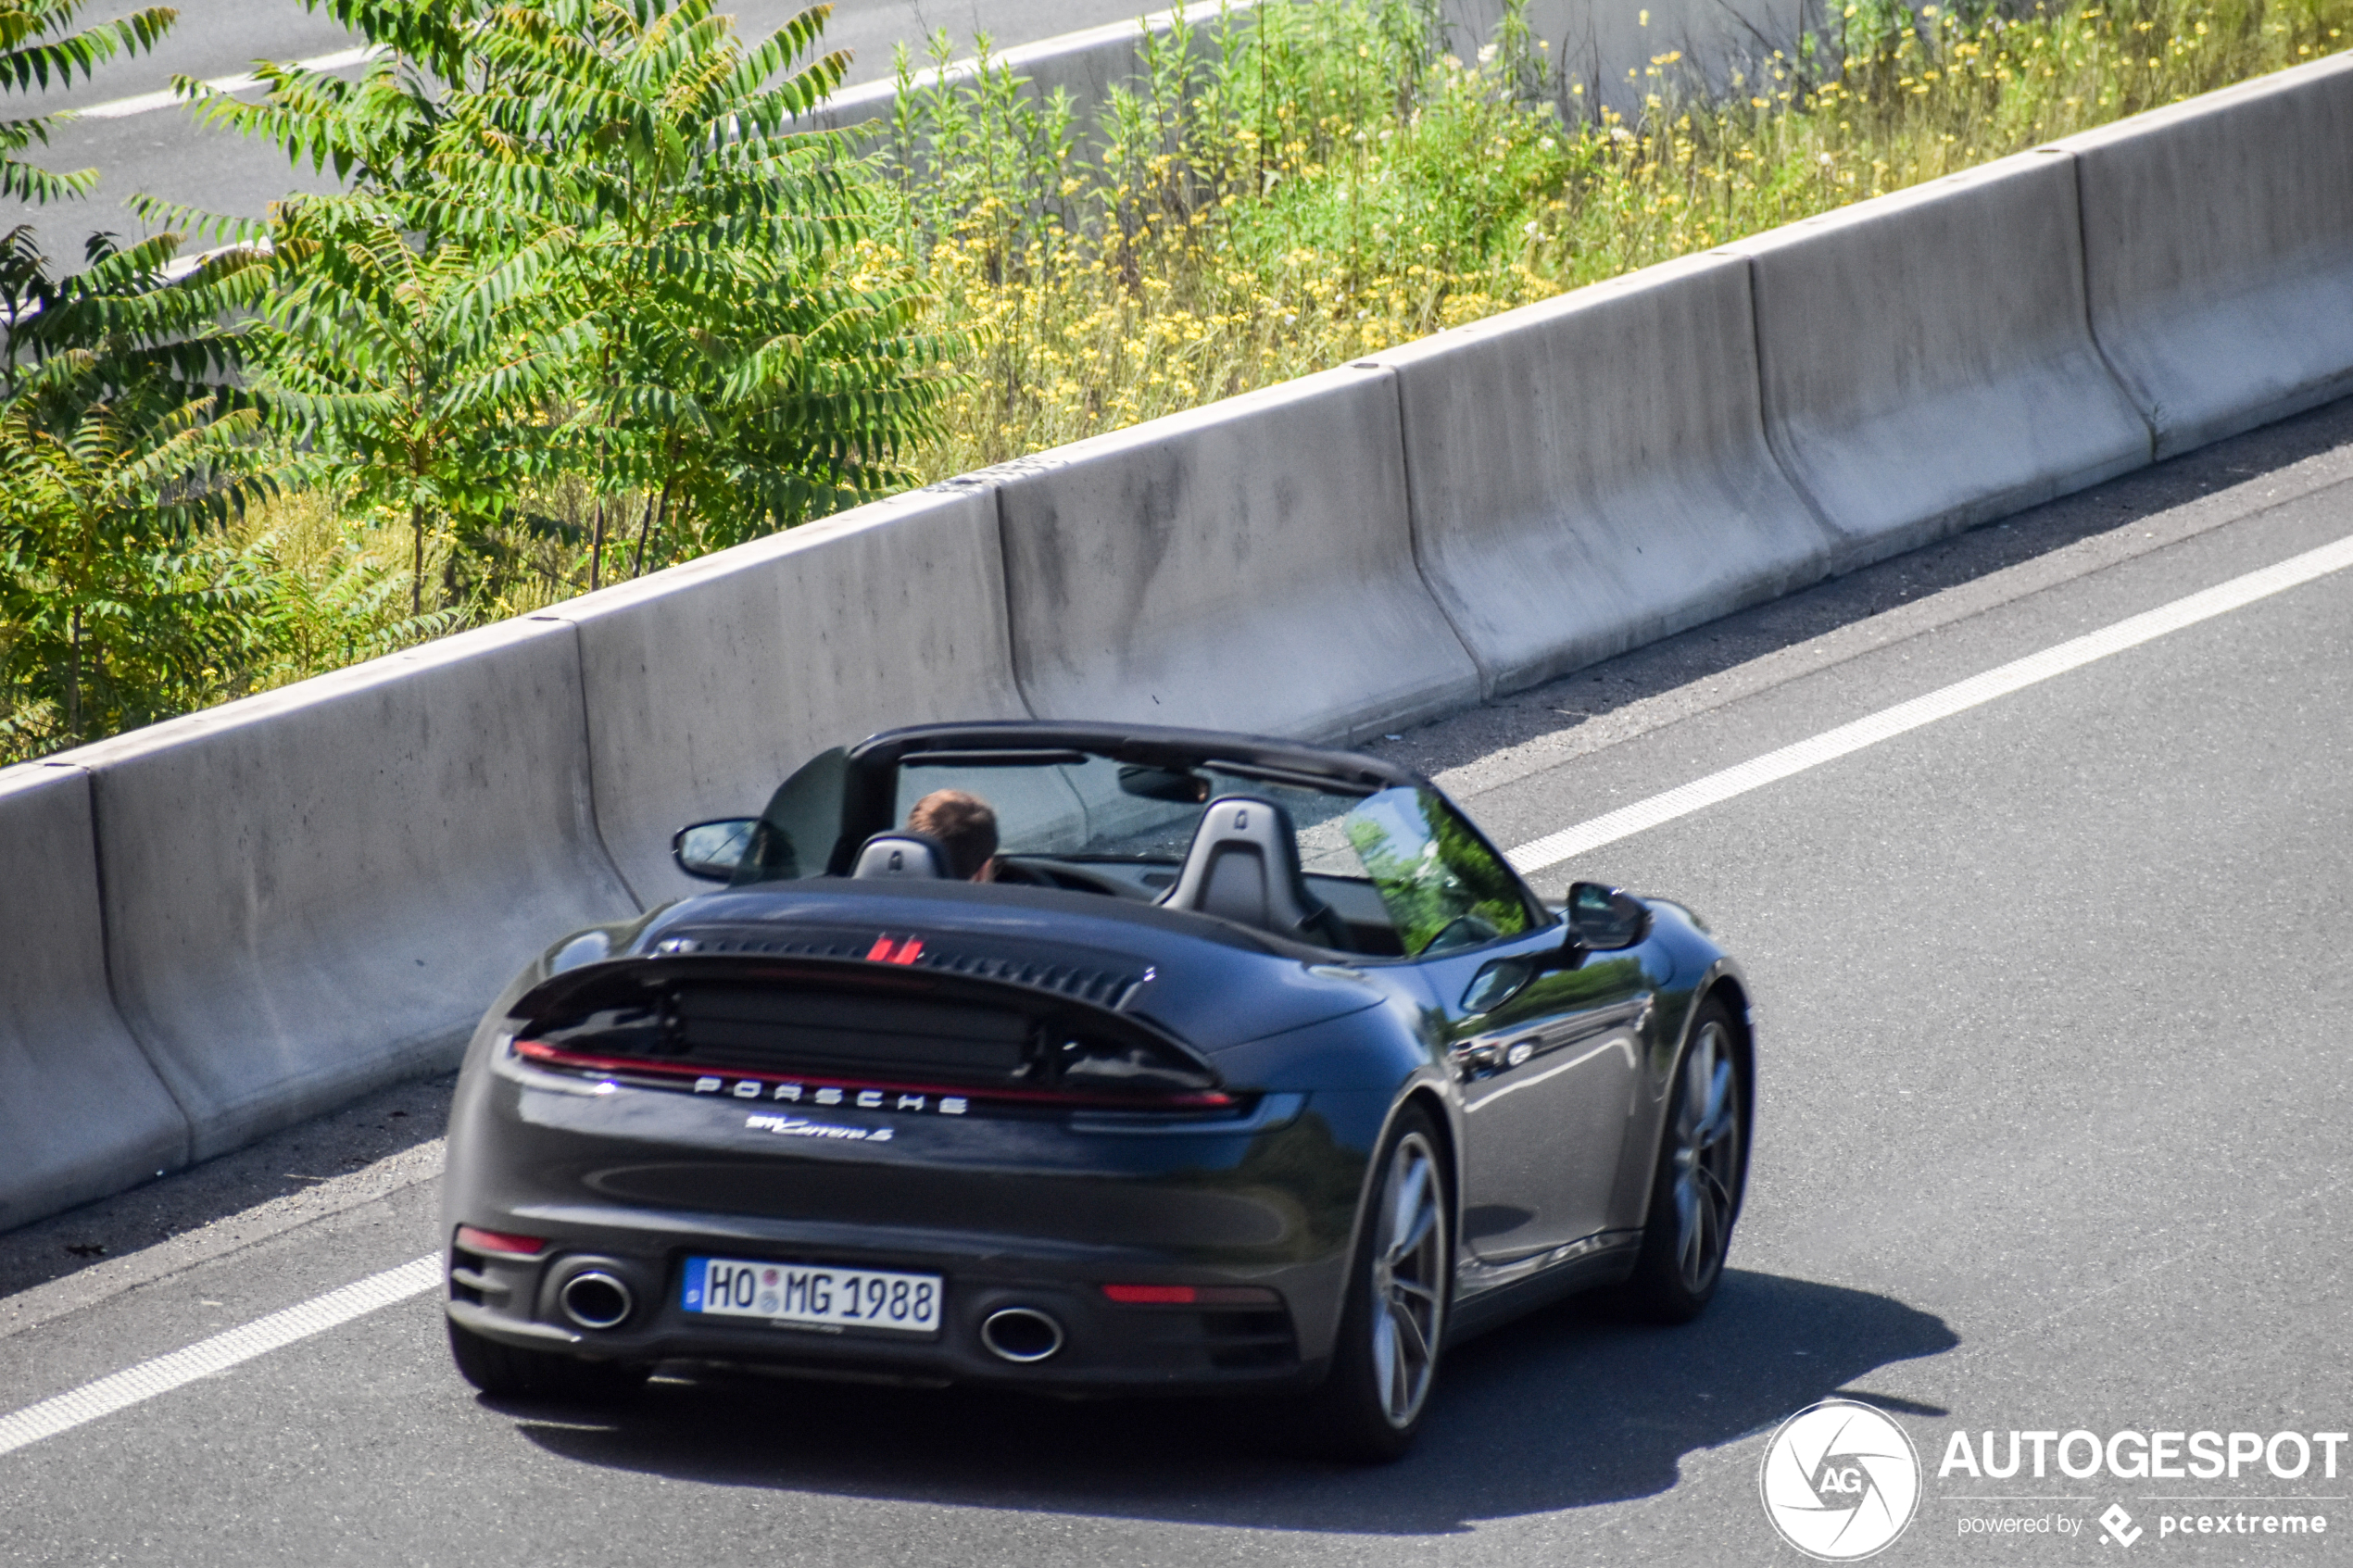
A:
443 1062 1386 1394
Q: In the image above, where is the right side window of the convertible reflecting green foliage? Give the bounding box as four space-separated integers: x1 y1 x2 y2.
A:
1343 785 1534 957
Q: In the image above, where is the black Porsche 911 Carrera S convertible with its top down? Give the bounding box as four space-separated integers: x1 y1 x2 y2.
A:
443 721 1755 1460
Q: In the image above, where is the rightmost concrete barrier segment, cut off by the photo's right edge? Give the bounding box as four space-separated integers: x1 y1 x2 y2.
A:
2057 54 2353 456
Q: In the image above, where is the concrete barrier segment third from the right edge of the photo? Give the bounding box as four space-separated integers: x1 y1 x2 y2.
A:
1378 257 1833 696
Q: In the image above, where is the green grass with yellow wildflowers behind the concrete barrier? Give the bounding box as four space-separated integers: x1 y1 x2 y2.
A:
871 0 2353 480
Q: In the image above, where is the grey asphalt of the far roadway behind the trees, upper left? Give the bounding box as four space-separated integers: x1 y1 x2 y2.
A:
0 0 1163 263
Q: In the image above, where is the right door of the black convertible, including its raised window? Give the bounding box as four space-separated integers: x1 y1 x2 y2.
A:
1346 787 1650 1262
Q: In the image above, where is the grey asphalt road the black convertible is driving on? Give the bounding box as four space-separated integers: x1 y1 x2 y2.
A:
0 405 2353 1568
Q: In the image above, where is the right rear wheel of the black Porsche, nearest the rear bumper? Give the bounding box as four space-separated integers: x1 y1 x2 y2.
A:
1299 1110 1454 1464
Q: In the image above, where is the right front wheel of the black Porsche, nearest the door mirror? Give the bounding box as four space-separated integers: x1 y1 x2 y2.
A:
1624 997 1748 1323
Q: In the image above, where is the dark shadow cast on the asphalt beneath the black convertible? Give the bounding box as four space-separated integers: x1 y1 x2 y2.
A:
506 1270 1960 1535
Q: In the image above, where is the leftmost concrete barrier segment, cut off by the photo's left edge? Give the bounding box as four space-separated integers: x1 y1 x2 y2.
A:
0 764 188 1229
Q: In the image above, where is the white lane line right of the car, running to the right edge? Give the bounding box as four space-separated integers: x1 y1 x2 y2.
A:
1508 526 2353 872
